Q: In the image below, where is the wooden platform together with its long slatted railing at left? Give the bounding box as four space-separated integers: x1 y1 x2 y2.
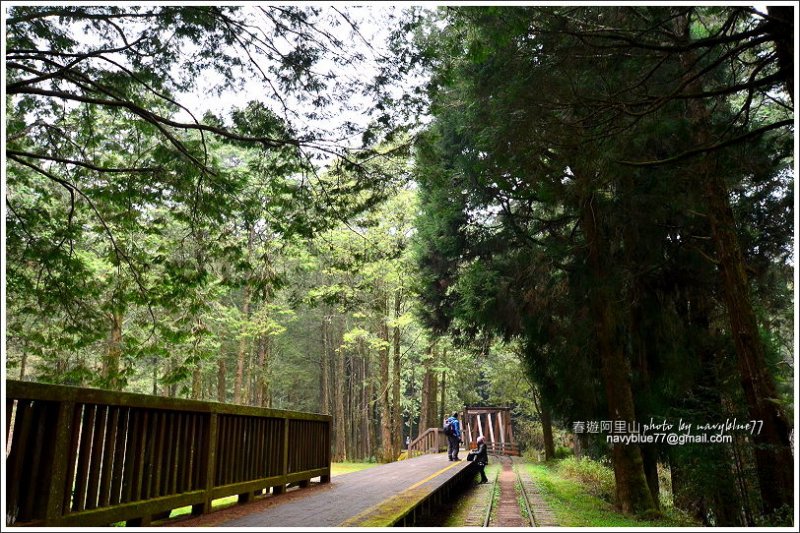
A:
5 380 475 527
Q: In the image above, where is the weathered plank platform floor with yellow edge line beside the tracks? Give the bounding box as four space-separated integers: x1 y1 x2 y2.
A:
166 453 474 528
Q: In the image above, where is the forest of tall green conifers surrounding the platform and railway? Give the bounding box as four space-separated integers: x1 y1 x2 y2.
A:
3 4 796 526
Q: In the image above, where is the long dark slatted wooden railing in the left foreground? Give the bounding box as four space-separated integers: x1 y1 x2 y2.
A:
5 380 331 526
